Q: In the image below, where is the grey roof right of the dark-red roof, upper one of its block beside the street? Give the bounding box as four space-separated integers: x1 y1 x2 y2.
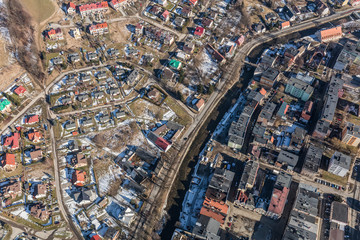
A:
294 187 319 217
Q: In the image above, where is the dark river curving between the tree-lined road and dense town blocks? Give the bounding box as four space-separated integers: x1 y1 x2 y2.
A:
160 21 338 240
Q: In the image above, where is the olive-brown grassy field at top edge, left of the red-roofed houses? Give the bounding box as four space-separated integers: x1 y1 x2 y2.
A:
21 0 55 23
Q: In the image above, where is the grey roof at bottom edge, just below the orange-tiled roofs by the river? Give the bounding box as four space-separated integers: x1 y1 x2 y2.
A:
193 215 220 240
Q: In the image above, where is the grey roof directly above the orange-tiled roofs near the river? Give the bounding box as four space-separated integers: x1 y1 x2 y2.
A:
209 168 235 193
